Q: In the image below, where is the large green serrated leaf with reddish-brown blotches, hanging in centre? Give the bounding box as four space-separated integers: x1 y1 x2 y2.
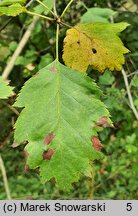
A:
15 61 109 190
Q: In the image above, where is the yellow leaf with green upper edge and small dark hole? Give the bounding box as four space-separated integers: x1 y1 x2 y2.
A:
63 23 129 72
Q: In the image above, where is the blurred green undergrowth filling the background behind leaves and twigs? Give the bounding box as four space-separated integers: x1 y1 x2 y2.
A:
0 0 138 199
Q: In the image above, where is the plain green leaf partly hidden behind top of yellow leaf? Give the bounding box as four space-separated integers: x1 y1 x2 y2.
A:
81 8 116 23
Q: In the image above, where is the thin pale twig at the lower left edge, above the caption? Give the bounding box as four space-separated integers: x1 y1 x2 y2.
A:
0 155 12 200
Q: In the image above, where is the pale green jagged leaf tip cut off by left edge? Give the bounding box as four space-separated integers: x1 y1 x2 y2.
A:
0 77 14 99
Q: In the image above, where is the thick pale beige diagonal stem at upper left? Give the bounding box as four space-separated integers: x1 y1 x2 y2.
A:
2 17 38 80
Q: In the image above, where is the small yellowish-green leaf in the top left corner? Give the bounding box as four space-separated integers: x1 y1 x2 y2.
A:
0 3 26 16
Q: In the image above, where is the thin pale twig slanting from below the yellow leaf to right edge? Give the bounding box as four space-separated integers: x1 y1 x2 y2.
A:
121 68 138 120
